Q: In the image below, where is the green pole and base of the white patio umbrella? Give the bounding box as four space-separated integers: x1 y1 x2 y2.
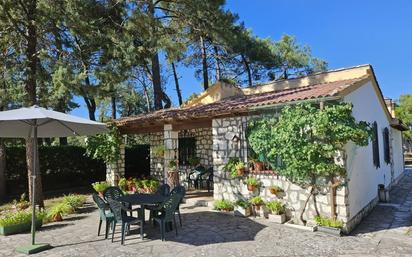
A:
16 120 52 254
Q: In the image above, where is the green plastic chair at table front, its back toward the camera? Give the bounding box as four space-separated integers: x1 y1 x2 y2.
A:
108 199 144 245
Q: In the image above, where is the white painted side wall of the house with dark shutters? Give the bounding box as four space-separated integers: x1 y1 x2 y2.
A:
344 82 403 219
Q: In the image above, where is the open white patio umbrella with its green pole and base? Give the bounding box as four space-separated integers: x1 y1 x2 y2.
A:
0 106 107 254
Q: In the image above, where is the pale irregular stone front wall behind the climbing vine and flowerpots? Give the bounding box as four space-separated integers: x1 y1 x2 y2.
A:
212 117 348 225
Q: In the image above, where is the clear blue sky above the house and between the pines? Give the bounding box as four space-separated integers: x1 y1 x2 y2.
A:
72 0 412 117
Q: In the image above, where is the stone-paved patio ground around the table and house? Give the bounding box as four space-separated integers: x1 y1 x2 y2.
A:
0 170 412 257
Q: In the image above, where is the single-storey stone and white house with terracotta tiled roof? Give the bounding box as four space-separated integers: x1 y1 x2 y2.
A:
108 65 406 231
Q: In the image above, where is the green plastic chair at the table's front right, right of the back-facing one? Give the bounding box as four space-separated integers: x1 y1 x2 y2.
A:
153 193 183 241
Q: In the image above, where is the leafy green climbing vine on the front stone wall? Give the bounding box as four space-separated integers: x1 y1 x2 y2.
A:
248 103 371 223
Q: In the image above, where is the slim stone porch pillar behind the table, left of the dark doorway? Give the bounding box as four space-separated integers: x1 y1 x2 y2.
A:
163 124 179 184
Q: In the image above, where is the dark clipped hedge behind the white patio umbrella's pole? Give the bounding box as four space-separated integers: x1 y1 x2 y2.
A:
6 146 106 194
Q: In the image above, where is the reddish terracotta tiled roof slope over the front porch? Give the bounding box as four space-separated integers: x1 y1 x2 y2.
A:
115 76 368 131
